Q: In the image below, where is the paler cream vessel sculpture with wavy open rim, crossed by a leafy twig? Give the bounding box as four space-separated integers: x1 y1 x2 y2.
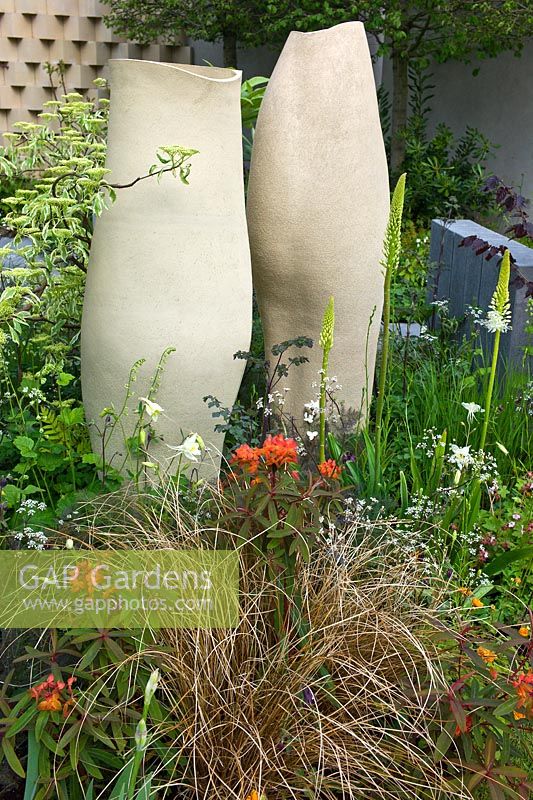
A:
81 60 252 476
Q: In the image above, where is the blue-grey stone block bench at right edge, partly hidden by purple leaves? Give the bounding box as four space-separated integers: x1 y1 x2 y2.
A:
428 220 533 369
